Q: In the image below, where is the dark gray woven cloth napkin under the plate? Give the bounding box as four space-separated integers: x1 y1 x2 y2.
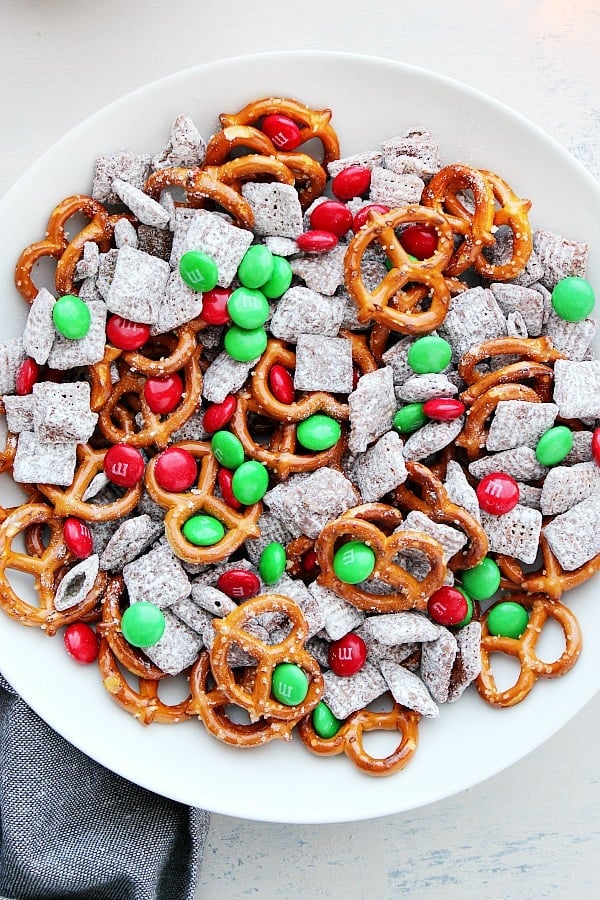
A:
0 676 209 900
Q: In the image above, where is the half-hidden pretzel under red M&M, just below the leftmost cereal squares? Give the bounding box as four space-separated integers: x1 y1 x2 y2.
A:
38 444 142 522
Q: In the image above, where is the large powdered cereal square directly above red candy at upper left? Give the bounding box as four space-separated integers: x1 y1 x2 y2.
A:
106 247 171 325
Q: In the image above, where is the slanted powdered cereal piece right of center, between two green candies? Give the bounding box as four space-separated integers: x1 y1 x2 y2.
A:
348 366 396 453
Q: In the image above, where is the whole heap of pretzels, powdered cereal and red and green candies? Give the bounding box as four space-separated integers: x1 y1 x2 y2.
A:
0 98 600 775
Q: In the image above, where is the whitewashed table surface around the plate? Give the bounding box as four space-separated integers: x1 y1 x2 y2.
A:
0 0 600 900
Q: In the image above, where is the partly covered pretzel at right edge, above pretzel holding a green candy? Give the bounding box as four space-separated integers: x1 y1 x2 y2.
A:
496 532 600 600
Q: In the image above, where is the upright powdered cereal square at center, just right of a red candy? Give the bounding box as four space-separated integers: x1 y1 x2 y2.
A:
294 334 353 394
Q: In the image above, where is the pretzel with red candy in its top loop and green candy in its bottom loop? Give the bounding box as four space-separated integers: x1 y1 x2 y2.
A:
145 441 262 565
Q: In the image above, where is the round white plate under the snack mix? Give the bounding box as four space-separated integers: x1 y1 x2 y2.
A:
0 53 600 822
